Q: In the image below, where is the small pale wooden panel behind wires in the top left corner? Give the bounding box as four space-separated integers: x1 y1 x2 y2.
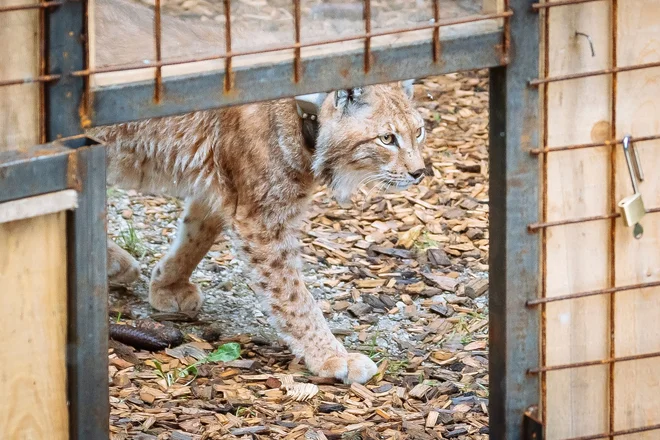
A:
0 0 40 151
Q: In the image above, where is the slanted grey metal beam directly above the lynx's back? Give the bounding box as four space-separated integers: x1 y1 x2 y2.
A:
91 30 506 126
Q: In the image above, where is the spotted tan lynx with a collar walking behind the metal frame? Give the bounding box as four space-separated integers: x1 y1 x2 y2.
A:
92 83 425 383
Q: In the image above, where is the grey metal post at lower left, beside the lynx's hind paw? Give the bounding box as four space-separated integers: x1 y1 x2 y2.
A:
67 145 110 440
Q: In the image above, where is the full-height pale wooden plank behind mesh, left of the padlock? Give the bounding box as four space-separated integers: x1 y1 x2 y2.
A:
544 2 611 440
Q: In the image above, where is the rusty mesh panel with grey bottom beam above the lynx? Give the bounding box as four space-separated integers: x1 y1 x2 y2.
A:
84 0 511 125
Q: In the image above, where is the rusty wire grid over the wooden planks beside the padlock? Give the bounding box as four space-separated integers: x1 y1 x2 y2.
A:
527 0 660 440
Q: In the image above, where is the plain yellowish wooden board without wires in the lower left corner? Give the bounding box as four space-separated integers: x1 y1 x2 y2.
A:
0 212 68 440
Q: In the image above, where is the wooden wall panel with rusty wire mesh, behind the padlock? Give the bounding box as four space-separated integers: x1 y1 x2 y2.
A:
528 0 660 440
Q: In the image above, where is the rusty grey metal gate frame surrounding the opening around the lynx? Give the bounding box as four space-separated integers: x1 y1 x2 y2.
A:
0 0 540 440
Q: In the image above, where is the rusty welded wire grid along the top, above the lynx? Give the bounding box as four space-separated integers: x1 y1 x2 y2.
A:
0 0 512 120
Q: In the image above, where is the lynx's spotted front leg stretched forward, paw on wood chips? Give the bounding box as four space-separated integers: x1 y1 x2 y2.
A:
235 219 377 383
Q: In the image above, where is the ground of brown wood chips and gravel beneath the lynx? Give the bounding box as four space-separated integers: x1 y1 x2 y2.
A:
108 72 488 440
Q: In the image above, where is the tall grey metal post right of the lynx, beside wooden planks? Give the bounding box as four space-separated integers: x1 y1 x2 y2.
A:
489 0 541 440
